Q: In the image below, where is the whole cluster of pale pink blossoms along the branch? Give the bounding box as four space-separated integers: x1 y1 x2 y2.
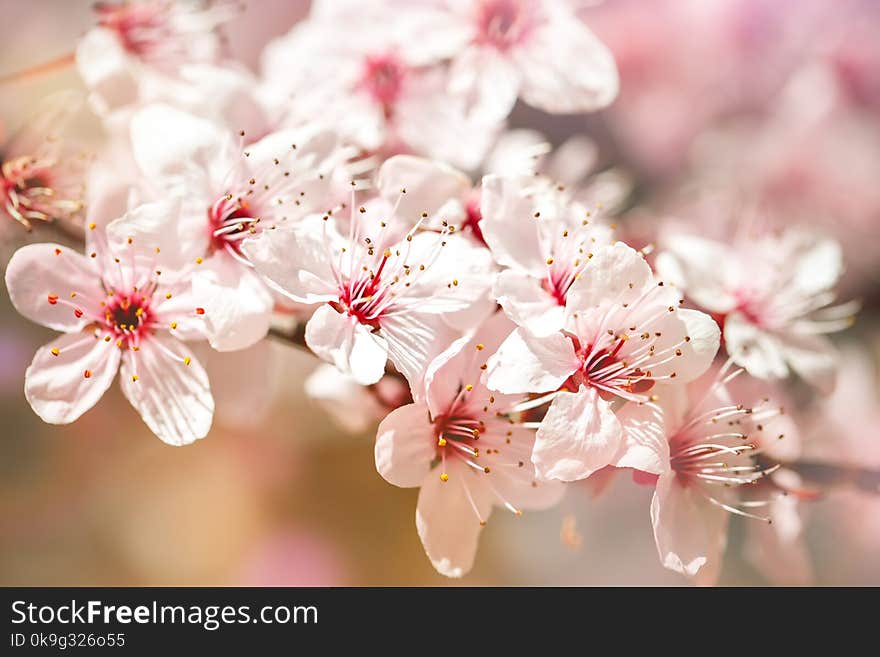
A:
0 0 868 583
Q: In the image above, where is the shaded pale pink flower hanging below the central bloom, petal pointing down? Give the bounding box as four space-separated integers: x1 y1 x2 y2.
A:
375 314 563 577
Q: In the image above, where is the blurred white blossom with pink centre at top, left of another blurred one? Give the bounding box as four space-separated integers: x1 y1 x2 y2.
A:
261 2 498 169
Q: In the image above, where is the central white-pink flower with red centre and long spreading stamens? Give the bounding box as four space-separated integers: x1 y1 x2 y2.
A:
243 158 492 386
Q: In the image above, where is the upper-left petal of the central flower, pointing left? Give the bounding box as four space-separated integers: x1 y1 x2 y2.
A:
242 219 338 303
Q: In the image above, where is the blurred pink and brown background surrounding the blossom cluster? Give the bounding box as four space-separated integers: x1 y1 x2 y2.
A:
0 0 880 585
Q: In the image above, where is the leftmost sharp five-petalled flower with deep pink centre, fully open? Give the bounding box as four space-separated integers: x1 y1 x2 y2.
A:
6 202 214 445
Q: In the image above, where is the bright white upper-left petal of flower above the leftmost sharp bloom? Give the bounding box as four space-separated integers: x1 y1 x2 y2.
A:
130 103 227 178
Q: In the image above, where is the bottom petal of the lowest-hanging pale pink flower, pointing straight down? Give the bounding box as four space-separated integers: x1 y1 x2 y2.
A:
416 465 492 577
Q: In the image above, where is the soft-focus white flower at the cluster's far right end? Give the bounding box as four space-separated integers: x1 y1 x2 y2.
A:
657 228 855 392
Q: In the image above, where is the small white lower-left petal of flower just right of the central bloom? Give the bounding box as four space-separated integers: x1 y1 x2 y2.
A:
493 269 565 336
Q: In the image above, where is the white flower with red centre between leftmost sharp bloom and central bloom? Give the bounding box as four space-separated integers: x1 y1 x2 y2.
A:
131 104 347 351
